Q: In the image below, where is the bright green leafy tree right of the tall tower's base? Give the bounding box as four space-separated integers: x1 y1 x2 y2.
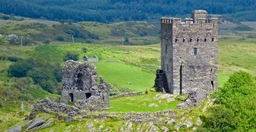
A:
200 71 256 132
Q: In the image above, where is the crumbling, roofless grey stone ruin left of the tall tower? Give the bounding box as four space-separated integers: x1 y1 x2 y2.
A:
62 60 110 110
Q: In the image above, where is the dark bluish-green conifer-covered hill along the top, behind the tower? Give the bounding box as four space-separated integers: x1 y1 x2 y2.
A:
0 0 256 23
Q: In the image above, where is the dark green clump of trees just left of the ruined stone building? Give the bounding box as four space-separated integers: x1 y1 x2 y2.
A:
8 58 62 94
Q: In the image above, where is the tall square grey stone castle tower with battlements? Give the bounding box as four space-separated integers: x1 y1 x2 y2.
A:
155 10 218 94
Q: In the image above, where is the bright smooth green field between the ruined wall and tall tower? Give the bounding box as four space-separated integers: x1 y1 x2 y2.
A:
94 62 155 91
